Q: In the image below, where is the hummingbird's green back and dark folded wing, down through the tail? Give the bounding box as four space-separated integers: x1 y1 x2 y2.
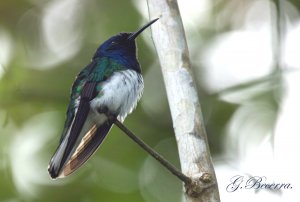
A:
48 59 124 178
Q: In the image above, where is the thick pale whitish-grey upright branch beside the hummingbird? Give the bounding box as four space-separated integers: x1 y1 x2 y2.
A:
147 0 220 202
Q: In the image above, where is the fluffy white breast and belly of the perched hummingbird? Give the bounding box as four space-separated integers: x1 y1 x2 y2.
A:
90 70 144 121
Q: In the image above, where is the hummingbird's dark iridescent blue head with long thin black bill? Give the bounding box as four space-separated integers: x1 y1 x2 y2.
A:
93 18 158 72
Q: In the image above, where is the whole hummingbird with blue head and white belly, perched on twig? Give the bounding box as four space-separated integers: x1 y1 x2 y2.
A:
48 18 158 179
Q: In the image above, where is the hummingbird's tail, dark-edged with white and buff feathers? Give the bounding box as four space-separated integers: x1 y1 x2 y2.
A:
48 115 112 179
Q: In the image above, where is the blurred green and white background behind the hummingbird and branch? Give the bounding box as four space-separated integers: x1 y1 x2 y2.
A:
0 0 300 202
